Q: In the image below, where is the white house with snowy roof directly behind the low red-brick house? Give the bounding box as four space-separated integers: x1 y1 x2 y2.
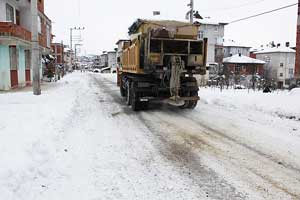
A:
223 40 251 58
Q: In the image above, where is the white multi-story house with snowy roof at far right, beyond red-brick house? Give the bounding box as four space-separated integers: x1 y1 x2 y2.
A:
255 47 296 88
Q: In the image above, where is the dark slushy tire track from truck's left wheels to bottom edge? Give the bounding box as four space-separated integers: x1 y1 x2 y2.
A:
94 74 247 200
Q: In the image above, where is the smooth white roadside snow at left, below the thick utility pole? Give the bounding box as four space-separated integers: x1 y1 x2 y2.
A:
0 74 80 199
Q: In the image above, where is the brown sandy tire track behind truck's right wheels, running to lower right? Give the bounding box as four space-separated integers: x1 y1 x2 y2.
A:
144 109 300 199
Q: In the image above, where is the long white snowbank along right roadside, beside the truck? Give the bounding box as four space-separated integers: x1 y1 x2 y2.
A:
199 88 300 120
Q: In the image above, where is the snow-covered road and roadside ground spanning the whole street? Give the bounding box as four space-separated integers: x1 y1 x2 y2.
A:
0 73 300 200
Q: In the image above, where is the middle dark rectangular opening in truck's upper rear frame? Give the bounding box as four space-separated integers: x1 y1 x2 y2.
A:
163 40 188 54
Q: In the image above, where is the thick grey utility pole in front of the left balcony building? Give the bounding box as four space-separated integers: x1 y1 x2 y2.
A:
31 0 41 95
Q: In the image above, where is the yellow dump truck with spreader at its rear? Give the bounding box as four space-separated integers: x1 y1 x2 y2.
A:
118 19 207 111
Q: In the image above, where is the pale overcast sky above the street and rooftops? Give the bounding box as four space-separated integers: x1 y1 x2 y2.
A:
45 0 297 54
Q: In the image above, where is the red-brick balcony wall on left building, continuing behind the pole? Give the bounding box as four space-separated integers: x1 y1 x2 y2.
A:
0 22 49 48
